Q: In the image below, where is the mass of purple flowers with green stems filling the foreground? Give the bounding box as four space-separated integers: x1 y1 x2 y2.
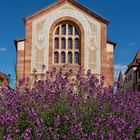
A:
0 69 140 140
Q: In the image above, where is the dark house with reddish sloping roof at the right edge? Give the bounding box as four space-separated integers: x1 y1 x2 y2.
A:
124 50 140 92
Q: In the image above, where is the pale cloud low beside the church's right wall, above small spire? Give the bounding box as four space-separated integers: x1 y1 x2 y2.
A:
114 64 127 81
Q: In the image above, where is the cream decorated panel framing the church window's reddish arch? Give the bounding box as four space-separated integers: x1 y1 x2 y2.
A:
31 4 100 74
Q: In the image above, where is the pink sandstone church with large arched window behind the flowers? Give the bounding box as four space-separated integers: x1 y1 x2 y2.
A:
15 0 116 85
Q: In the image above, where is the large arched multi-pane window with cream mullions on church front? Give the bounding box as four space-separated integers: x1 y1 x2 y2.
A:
53 22 81 65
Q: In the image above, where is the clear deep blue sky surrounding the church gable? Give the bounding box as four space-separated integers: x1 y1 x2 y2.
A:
0 0 140 85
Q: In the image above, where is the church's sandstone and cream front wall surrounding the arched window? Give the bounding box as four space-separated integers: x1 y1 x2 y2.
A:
17 3 114 85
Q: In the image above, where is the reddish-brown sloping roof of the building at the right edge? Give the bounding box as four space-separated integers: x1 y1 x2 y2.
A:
125 50 140 74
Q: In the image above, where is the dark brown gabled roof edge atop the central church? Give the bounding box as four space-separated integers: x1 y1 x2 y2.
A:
24 0 109 25
